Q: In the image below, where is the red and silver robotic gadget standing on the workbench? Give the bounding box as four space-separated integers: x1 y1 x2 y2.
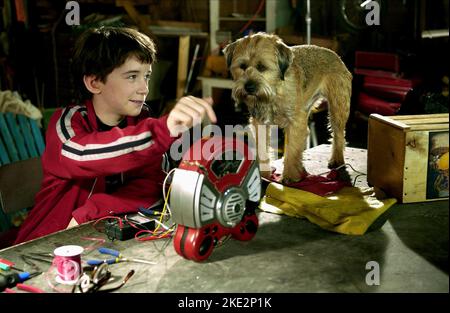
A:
170 137 261 261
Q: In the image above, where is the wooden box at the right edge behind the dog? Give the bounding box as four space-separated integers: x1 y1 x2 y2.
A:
367 114 449 203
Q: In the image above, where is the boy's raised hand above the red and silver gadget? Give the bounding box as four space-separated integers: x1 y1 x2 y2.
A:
167 96 217 137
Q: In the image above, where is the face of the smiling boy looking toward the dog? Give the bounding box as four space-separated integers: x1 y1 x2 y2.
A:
93 56 152 124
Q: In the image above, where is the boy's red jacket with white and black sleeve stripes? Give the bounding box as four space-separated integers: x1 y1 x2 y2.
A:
15 101 176 244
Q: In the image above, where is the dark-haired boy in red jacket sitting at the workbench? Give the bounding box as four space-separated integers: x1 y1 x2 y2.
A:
15 27 216 244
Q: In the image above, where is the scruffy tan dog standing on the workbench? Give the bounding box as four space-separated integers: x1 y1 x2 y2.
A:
223 33 352 182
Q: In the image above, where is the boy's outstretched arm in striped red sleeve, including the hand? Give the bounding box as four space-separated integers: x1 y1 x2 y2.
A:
46 96 216 178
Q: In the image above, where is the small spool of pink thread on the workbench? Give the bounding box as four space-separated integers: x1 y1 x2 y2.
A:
53 245 84 285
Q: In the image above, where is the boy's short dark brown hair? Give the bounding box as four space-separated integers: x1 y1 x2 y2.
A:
72 26 156 102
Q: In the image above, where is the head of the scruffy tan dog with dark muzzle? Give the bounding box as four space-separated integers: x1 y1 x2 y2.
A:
223 33 293 122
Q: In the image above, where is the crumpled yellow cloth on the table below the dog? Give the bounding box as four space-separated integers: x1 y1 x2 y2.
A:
260 183 397 235
